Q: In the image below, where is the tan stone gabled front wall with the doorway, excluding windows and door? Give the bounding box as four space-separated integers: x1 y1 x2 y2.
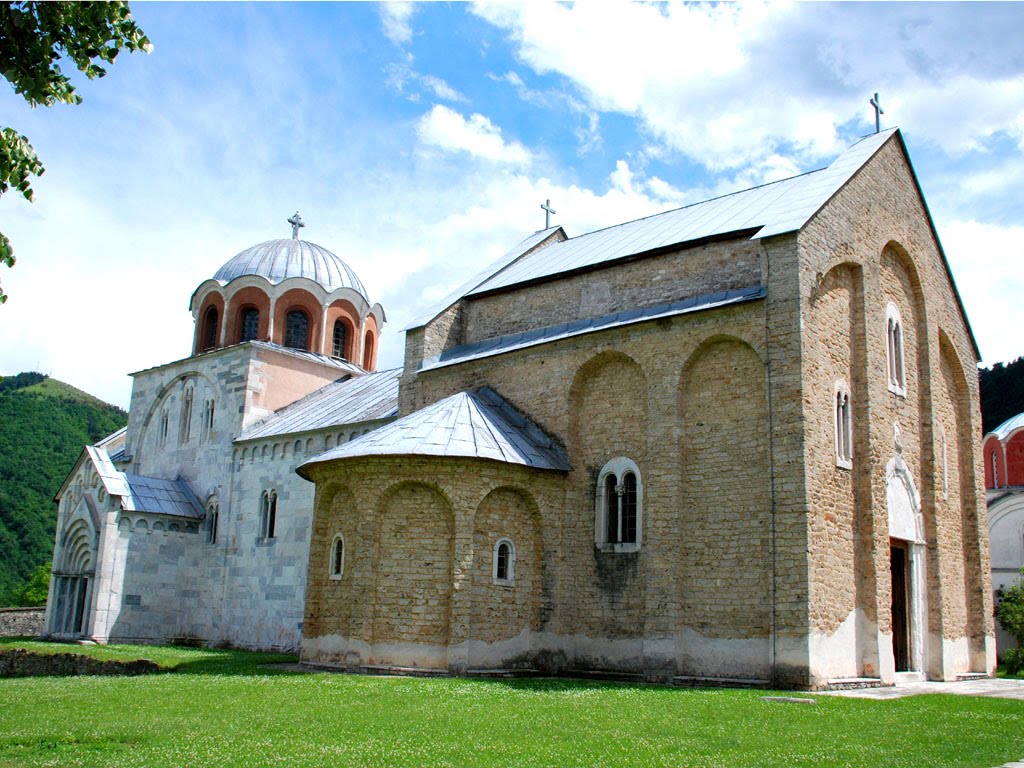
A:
800 135 991 679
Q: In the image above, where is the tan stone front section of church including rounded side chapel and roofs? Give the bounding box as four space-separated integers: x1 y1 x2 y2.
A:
298 129 995 689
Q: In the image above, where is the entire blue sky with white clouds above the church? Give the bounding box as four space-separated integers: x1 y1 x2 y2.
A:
0 2 1024 406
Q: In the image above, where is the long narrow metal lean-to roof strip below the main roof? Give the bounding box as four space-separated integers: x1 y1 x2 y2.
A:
420 286 767 371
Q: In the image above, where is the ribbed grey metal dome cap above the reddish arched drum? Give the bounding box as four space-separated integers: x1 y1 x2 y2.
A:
213 238 369 300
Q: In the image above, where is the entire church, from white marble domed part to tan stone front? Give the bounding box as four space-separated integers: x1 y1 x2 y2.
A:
47 129 994 688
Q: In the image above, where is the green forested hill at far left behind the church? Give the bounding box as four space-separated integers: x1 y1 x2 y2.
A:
0 373 128 606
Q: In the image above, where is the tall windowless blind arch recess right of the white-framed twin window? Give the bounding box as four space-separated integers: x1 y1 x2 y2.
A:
679 334 772 643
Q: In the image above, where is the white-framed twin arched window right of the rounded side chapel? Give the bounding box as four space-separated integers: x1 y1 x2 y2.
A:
594 457 643 552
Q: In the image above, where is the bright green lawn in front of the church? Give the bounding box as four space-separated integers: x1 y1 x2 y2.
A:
0 642 1024 768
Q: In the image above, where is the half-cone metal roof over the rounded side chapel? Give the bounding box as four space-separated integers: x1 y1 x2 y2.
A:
299 387 571 477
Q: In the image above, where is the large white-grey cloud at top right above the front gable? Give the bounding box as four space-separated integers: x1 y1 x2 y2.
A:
474 3 1024 172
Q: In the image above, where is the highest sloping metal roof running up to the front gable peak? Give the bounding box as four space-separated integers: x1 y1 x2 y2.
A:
465 128 897 296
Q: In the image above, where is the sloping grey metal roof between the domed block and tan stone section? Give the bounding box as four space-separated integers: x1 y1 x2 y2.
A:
237 368 401 440
